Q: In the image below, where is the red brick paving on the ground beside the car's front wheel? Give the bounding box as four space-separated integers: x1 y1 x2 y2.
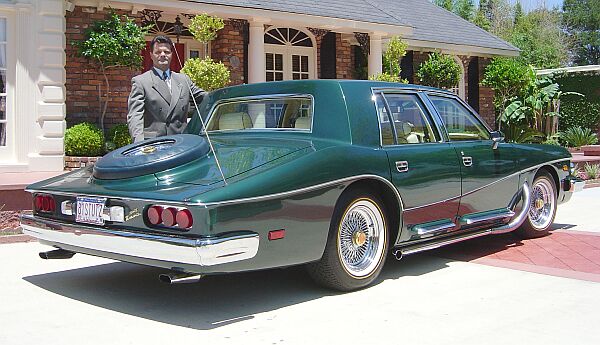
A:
434 230 600 282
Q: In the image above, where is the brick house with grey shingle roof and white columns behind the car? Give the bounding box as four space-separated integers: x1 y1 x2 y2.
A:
0 0 518 172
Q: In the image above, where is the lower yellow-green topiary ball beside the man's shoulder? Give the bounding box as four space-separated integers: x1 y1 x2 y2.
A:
181 58 230 91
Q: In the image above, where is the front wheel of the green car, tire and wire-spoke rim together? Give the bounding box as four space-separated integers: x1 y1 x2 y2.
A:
515 171 557 238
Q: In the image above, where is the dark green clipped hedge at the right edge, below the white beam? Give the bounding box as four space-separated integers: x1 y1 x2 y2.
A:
558 99 600 130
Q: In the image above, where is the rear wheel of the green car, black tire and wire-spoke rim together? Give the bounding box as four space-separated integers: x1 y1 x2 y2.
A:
307 189 389 291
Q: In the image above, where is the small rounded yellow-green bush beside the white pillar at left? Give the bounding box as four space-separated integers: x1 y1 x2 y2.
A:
65 122 104 157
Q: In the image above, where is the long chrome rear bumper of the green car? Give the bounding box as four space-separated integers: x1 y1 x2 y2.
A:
21 215 259 266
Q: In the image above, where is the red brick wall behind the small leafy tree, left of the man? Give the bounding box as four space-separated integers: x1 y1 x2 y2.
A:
65 6 141 128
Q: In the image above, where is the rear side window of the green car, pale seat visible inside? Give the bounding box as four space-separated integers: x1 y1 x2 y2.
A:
376 93 438 145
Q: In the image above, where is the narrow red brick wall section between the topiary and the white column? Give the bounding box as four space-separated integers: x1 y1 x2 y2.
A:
211 20 246 85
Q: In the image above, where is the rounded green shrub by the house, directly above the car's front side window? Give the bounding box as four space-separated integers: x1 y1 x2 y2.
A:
416 52 461 88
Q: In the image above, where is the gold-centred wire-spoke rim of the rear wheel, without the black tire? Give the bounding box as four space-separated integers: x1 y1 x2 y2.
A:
338 199 386 277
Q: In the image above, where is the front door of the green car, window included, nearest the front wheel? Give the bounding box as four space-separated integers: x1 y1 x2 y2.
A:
429 94 519 219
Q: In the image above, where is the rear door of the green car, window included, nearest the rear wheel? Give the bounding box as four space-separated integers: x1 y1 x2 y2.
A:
376 92 461 242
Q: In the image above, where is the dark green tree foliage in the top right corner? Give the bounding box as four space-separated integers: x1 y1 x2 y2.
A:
563 0 600 65
